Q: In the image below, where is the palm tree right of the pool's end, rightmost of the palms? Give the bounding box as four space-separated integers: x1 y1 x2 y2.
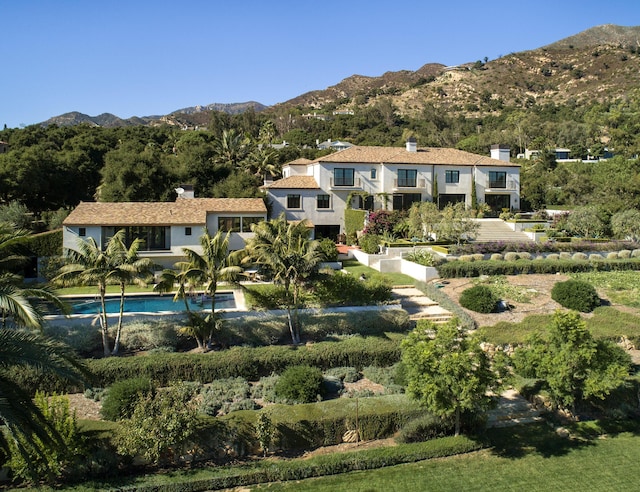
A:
246 214 324 344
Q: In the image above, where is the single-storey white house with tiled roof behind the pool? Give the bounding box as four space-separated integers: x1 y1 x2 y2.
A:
63 192 267 267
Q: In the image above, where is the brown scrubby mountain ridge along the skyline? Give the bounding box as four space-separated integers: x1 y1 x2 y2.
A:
44 24 640 127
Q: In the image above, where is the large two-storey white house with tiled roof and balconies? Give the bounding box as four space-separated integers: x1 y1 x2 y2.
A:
263 138 520 239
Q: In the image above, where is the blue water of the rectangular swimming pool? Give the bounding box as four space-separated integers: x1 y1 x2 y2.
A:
70 292 236 314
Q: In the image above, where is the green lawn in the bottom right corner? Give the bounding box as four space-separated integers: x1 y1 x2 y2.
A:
251 424 640 492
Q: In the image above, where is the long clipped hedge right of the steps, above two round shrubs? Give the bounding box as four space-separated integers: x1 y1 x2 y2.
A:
436 258 640 278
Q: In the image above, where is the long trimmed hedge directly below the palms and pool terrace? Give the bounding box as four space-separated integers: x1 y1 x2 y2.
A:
88 336 400 387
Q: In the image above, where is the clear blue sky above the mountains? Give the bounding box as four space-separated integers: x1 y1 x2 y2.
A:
0 0 640 128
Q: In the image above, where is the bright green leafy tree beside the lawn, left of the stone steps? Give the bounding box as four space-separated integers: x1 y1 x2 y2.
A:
402 318 499 436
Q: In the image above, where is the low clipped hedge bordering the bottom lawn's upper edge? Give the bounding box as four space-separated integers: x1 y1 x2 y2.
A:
116 436 483 492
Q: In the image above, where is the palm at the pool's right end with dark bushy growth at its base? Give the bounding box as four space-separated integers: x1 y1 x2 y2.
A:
155 230 242 350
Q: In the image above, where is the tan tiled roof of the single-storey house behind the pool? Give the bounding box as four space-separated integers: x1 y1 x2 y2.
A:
63 198 267 226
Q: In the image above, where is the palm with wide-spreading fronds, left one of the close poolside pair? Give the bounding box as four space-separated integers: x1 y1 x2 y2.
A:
53 230 124 356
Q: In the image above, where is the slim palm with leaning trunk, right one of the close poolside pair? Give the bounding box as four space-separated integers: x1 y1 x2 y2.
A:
111 234 154 355
